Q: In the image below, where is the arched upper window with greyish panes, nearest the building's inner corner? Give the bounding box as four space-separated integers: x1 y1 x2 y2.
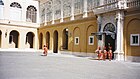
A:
26 5 37 23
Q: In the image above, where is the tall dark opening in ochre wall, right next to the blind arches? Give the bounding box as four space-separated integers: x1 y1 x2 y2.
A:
62 29 68 50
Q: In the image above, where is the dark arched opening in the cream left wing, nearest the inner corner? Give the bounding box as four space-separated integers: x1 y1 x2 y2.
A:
26 32 34 48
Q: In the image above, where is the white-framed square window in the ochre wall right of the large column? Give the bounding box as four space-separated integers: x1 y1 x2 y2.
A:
130 34 140 46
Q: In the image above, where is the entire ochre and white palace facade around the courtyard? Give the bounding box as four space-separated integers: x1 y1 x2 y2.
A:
0 0 140 61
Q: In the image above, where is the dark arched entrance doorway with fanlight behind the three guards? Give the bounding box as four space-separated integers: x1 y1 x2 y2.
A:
103 23 116 58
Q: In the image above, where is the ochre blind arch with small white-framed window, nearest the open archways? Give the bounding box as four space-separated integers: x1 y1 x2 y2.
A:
73 27 81 52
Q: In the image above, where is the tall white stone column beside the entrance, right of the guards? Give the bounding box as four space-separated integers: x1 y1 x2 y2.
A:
114 11 124 61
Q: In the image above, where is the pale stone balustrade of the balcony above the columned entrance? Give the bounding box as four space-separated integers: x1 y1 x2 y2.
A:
93 0 140 14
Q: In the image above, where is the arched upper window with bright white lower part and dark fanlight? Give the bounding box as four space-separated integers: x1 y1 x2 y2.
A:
10 2 22 21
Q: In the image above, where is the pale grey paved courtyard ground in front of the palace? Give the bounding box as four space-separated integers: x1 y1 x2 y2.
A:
0 52 140 79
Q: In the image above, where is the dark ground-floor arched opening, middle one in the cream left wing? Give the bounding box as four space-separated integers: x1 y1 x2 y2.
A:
9 30 19 48
